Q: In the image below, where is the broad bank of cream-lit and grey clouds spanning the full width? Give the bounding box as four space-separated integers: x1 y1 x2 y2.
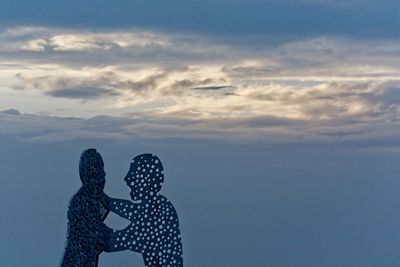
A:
0 27 400 137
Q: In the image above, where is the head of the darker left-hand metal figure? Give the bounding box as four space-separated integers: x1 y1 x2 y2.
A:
79 148 106 189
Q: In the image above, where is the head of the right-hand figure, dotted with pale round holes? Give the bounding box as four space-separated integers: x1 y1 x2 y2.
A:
124 154 164 201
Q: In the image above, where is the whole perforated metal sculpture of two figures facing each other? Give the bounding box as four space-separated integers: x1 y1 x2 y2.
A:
61 152 183 267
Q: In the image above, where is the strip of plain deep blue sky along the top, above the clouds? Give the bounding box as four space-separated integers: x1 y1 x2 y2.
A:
0 0 399 37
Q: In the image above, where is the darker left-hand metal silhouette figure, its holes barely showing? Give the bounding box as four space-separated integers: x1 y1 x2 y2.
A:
61 149 112 267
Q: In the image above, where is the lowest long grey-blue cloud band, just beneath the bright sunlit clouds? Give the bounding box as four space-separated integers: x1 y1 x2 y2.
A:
0 106 400 146
